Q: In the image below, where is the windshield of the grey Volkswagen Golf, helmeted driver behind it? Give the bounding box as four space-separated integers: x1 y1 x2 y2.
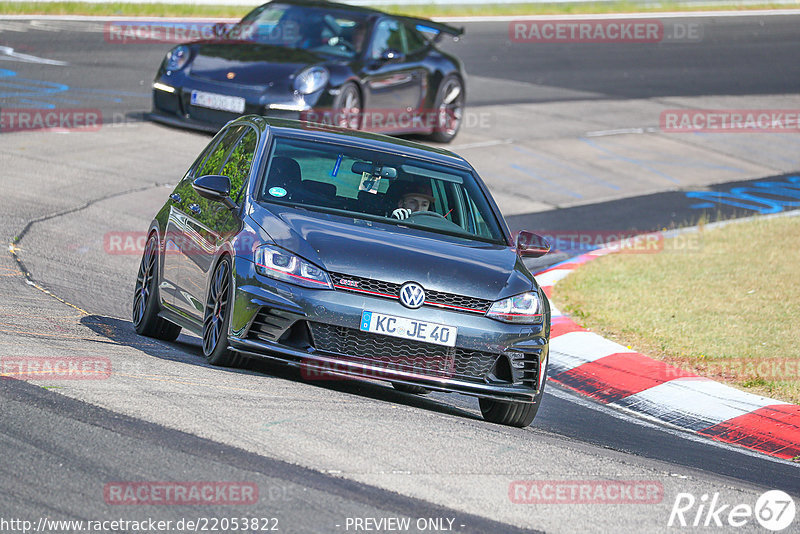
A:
258 137 506 244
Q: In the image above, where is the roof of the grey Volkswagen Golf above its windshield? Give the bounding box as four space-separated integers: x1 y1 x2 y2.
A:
247 115 472 171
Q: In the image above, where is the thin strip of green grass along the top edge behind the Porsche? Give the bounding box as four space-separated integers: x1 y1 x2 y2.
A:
0 1 800 18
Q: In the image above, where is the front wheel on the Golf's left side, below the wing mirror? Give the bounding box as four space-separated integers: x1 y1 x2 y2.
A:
203 256 246 367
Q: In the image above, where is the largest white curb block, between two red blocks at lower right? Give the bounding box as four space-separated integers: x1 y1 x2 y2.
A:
610 378 786 430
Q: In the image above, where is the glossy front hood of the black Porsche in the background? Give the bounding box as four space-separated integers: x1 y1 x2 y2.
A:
191 41 324 86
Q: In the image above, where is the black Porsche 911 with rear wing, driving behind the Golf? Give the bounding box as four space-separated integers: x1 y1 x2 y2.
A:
152 0 466 142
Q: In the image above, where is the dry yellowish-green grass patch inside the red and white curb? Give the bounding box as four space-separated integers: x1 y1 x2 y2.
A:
553 217 800 403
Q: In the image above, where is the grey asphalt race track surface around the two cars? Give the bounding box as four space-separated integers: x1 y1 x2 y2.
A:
0 15 800 532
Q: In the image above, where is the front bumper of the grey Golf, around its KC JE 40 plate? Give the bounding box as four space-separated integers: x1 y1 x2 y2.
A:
229 257 549 402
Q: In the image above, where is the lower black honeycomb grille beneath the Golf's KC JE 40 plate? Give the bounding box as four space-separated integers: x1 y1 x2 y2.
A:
308 322 498 382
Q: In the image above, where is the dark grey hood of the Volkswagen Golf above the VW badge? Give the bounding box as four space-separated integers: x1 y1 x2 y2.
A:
251 204 536 300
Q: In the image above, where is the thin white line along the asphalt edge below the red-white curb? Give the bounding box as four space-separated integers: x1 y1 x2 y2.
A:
544 384 797 468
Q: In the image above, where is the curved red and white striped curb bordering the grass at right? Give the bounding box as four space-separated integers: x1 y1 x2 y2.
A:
536 248 800 459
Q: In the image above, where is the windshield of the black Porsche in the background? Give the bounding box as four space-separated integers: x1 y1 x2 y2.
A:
228 3 366 57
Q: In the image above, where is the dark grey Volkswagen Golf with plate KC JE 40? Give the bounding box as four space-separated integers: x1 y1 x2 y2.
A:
133 115 550 426
